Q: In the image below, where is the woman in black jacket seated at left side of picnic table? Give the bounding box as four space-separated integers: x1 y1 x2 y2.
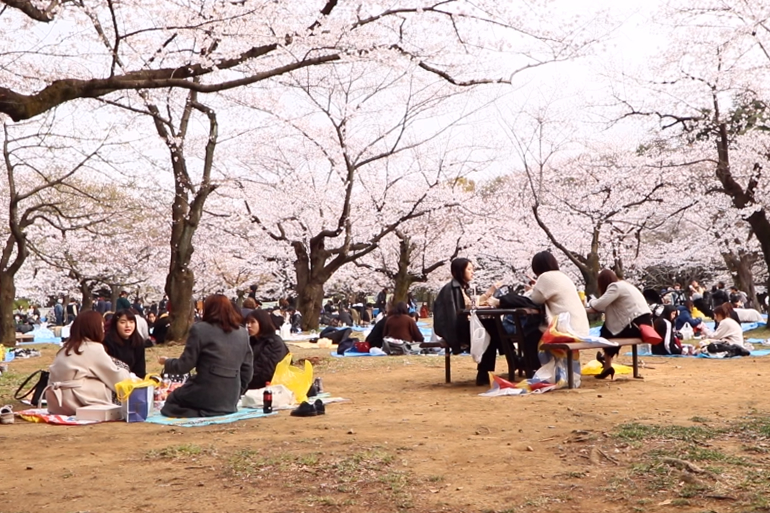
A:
433 258 502 386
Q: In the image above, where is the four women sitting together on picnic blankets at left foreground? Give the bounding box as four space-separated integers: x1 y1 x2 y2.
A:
45 294 289 417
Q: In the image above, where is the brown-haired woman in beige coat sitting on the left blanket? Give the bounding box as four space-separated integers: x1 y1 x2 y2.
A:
43 310 130 415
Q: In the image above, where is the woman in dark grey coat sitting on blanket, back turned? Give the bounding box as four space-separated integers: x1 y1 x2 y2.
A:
158 294 254 418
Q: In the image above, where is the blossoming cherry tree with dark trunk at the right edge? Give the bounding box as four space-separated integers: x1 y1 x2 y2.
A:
616 0 770 290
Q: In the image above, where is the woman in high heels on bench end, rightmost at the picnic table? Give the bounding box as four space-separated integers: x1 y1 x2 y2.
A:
587 269 652 379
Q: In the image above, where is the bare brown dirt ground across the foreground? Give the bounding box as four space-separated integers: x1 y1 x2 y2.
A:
0 340 770 513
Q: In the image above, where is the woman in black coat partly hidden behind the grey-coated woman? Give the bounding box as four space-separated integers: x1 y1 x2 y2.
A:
246 310 289 390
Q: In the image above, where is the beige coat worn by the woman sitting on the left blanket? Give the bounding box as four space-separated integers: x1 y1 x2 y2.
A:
45 341 129 415
